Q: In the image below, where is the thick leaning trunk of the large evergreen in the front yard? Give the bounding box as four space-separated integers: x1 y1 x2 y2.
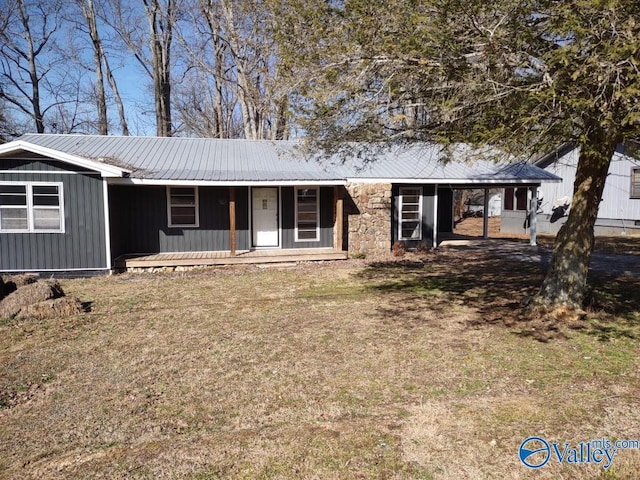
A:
536 127 618 308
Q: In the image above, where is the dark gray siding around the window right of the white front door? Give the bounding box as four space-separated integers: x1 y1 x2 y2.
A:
280 187 333 248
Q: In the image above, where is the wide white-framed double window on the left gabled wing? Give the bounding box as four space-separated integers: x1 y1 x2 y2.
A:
0 182 64 233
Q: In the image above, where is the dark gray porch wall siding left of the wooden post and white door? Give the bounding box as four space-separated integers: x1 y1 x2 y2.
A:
109 185 250 258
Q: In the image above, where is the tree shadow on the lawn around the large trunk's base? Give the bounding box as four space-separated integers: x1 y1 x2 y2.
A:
360 251 640 341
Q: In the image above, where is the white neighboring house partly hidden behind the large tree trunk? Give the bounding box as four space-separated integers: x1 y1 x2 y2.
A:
500 144 640 235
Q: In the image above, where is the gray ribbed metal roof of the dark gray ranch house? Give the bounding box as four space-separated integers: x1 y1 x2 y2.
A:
11 134 560 184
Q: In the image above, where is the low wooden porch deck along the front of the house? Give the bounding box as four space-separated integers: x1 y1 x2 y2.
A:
115 248 348 269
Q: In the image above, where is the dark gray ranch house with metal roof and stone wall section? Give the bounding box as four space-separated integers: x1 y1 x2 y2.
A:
0 134 559 272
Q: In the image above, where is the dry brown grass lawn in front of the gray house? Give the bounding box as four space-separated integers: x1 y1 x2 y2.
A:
0 252 640 479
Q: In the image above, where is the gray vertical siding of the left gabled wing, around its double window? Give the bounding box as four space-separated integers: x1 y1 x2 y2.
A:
0 158 107 271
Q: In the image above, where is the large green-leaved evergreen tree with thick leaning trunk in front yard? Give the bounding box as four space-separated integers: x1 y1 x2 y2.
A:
274 0 640 307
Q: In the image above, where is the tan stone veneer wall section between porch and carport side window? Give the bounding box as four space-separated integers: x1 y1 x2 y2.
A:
345 183 391 257
